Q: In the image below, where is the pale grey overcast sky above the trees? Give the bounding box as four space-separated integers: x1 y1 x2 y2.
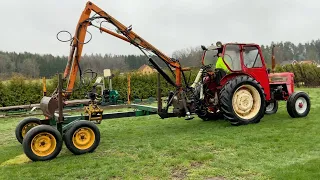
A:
0 0 320 56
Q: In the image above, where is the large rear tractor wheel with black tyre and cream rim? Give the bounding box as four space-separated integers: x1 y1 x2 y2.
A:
219 75 266 125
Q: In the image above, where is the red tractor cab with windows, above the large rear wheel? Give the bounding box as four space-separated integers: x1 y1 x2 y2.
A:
202 42 270 100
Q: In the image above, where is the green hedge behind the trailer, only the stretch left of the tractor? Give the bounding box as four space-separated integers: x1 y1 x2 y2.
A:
0 69 197 107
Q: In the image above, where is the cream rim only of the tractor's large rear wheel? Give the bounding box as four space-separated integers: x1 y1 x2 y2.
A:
232 85 261 120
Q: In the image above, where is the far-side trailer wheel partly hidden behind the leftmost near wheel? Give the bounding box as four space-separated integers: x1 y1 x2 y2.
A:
15 117 41 144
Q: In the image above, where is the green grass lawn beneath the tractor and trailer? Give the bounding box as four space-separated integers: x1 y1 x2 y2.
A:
0 89 320 179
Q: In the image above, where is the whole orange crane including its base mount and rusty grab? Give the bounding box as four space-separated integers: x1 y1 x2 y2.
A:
40 1 194 117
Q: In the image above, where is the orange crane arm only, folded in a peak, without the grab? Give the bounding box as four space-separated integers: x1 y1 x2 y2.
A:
64 1 184 96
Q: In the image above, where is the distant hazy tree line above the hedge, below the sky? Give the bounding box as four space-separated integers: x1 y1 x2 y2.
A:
0 39 320 79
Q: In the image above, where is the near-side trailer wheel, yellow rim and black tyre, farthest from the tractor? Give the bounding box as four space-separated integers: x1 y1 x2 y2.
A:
22 125 63 161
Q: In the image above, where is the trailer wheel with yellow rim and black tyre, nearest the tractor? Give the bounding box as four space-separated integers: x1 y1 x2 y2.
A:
64 120 100 155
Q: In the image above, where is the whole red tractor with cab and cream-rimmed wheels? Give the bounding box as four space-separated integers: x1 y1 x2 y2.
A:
192 42 310 125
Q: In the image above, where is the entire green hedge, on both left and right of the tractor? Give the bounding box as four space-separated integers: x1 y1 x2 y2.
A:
0 64 320 107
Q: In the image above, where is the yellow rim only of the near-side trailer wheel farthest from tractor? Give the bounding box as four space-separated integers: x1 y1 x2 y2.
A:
31 132 57 157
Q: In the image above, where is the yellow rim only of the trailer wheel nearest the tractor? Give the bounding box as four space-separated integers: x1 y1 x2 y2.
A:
72 127 96 150
